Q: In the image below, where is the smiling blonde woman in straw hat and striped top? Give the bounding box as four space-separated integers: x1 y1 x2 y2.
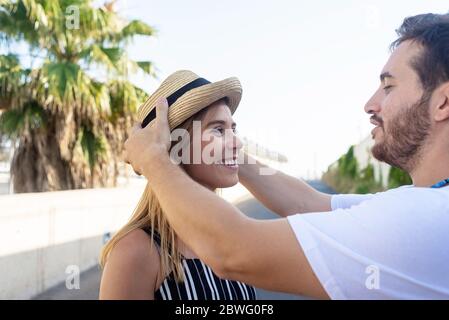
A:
100 71 256 300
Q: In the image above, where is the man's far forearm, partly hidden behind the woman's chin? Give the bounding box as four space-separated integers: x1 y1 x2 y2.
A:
239 154 331 217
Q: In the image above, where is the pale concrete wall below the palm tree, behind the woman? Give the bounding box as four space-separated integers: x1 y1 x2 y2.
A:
0 180 144 299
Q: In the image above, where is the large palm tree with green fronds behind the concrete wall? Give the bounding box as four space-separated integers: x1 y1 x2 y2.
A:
0 0 155 192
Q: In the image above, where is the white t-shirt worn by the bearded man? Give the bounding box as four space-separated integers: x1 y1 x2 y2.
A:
288 186 449 299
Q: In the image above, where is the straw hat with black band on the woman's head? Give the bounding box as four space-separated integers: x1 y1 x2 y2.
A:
137 70 242 129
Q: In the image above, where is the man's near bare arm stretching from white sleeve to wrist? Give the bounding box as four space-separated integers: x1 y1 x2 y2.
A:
143 154 328 298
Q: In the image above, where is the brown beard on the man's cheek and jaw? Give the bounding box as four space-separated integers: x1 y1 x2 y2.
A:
371 94 431 172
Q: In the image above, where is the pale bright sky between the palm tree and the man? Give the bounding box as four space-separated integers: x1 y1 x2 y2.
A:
10 0 449 177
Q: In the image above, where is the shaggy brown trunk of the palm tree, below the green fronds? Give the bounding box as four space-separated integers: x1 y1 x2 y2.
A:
11 108 125 193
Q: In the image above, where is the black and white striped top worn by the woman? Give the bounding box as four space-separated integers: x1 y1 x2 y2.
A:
144 228 257 300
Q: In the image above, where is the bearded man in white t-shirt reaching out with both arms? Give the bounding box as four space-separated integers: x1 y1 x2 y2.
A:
125 14 449 299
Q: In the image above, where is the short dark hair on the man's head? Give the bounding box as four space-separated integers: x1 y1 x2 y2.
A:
391 13 449 93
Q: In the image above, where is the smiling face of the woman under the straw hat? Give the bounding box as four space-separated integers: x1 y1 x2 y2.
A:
183 100 242 190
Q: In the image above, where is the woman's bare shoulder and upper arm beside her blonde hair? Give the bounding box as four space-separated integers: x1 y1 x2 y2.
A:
100 229 160 299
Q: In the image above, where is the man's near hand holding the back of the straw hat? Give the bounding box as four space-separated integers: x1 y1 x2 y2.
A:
124 98 171 175
